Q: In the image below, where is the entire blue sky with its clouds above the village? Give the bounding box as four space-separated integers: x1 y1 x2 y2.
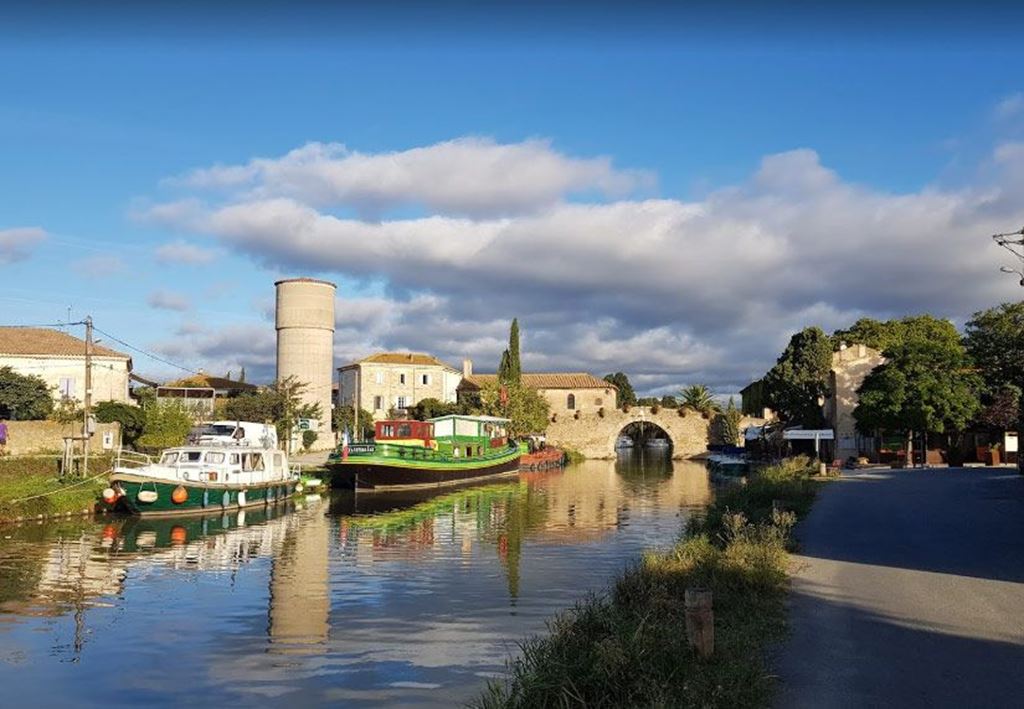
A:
0 5 1024 390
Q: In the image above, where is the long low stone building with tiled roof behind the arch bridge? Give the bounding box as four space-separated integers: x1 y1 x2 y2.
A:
459 360 618 415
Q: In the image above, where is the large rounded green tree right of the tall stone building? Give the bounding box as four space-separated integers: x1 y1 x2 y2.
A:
853 338 982 462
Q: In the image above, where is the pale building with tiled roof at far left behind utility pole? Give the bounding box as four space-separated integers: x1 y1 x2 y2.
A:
0 327 132 403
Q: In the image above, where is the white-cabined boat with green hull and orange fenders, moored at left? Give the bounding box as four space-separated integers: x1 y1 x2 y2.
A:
102 444 302 515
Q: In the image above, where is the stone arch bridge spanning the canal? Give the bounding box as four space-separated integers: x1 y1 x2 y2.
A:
547 406 764 459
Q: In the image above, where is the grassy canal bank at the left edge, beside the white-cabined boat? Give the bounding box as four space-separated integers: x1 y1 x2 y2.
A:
0 455 111 522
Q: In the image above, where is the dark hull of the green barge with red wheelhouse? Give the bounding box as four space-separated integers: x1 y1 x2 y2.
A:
328 453 519 492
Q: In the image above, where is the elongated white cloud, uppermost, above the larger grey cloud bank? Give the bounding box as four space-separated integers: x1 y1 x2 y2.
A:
166 137 652 217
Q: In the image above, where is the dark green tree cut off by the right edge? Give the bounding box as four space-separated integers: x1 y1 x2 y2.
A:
965 301 1024 473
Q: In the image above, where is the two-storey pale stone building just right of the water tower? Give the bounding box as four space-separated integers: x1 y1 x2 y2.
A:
337 352 462 420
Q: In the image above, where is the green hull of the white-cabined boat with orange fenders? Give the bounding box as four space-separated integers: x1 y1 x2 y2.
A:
111 473 298 516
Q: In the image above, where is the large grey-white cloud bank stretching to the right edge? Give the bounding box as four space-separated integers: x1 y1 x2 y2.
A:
138 141 1024 391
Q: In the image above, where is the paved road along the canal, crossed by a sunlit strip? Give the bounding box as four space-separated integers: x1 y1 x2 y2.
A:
775 468 1024 709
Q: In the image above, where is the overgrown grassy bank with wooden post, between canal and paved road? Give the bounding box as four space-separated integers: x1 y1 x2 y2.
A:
474 458 817 707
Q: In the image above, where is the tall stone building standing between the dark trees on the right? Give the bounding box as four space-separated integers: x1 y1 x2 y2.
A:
823 342 886 460
